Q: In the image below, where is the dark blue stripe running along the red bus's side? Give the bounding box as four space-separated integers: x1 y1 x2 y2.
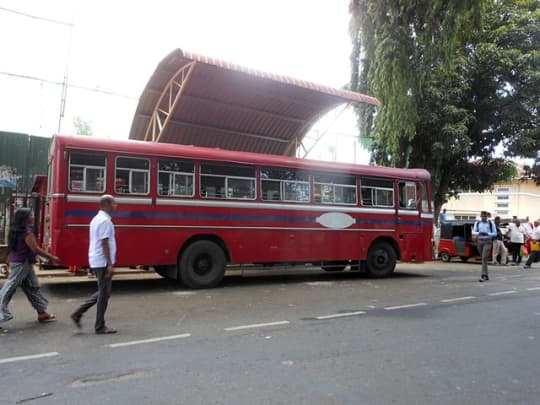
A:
65 210 431 226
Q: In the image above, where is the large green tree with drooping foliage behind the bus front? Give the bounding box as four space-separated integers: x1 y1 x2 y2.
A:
351 0 540 218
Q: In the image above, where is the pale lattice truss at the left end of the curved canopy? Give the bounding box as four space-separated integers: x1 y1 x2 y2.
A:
144 61 196 142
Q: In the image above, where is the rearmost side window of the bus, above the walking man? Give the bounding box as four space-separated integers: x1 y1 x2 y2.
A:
68 152 107 193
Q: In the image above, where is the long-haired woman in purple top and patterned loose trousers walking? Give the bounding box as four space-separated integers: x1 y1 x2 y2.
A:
0 208 59 329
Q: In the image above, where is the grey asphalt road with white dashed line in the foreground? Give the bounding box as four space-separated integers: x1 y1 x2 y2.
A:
0 262 540 405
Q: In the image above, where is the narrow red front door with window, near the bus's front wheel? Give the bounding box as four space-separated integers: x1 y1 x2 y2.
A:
396 180 422 261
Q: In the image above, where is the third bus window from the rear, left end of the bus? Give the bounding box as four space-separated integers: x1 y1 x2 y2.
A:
158 159 195 197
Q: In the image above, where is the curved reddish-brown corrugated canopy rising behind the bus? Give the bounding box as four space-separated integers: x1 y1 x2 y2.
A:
129 49 379 156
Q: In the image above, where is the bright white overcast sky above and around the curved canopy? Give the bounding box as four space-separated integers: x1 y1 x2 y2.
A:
0 0 369 163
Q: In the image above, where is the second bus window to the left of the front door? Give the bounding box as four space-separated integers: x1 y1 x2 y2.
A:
313 174 357 205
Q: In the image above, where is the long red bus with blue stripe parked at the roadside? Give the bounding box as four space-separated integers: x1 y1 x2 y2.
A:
44 136 433 288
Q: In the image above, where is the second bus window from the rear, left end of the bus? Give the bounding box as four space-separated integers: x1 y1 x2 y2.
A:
114 157 150 194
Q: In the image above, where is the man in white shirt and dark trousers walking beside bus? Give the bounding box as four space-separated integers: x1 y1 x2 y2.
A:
71 194 116 334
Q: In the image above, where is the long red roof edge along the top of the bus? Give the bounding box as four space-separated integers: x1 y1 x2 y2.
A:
54 135 430 180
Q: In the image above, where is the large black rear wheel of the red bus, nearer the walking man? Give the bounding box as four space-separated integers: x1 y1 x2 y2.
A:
178 240 227 288
